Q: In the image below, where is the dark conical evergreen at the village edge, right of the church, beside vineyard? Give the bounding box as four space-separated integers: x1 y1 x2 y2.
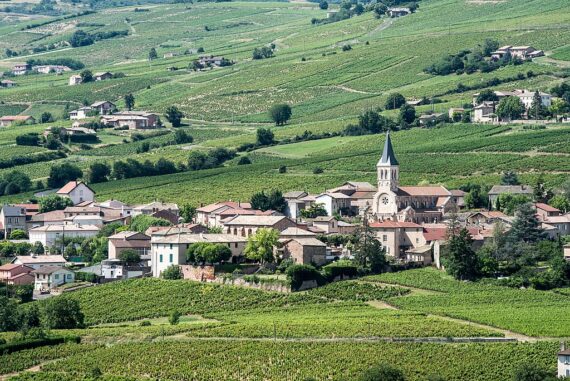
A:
444 228 479 280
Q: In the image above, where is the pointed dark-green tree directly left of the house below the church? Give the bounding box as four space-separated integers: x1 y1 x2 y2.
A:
353 214 386 273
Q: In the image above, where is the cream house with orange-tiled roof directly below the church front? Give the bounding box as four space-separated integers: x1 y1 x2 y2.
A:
369 220 431 258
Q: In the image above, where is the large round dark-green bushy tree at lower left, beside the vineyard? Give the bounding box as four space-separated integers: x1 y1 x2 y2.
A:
42 297 84 329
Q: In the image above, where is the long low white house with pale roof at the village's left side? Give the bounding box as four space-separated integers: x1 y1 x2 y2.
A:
29 224 99 249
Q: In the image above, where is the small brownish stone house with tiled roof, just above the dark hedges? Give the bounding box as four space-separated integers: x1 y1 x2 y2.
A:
278 237 327 266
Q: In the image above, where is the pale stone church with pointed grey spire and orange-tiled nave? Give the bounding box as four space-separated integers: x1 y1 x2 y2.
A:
372 132 456 224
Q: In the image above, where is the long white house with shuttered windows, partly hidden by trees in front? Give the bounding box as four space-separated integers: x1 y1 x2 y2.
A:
151 234 247 277
